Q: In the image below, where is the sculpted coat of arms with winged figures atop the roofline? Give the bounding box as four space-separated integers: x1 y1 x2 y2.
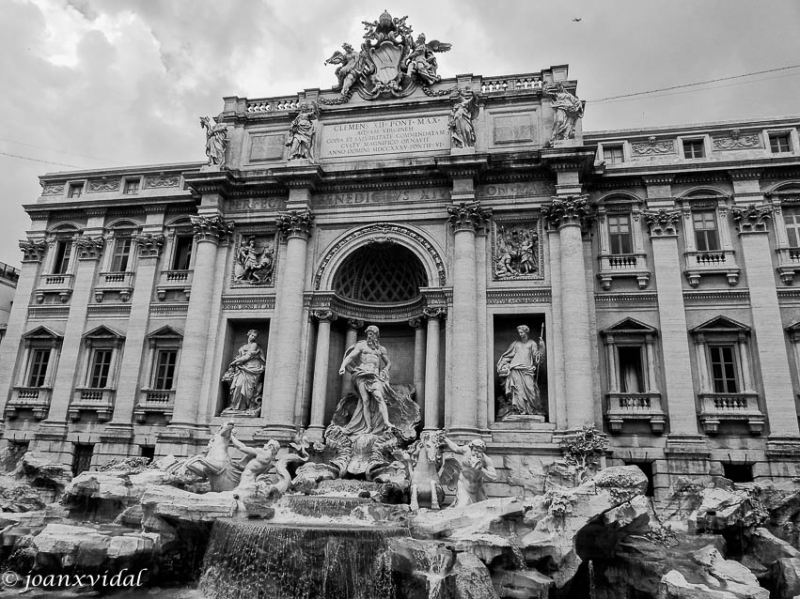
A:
325 11 452 103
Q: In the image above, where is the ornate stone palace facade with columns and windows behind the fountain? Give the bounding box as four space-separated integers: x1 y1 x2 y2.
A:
0 20 800 494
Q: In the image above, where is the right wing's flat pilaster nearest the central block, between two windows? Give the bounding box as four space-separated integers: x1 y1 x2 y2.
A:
644 209 705 438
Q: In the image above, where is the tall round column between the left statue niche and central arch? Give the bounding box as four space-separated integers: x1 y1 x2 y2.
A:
265 211 314 436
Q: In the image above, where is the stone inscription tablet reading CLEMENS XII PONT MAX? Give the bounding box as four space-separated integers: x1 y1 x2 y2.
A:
320 116 449 158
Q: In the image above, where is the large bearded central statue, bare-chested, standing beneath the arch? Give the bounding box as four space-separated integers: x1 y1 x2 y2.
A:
339 325 397 434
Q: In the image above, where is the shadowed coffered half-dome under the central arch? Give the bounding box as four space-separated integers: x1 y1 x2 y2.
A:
333 242 428 304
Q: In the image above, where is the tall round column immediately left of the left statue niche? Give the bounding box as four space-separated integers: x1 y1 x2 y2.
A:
170 213 233 430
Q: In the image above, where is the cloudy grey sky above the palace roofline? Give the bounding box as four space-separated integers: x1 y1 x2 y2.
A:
0 0 800 265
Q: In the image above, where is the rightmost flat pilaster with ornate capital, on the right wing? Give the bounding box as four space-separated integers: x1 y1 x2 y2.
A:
733 204 800 442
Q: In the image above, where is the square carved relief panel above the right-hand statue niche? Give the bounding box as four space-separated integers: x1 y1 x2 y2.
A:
492 219 544 281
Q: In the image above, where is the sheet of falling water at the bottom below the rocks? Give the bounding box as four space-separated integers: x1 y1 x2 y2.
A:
200 519 408 599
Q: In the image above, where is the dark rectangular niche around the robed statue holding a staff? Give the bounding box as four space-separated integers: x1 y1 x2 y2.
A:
491 314 553 428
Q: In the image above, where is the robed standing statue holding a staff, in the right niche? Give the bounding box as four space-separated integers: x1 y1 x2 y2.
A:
497 325 545 420
